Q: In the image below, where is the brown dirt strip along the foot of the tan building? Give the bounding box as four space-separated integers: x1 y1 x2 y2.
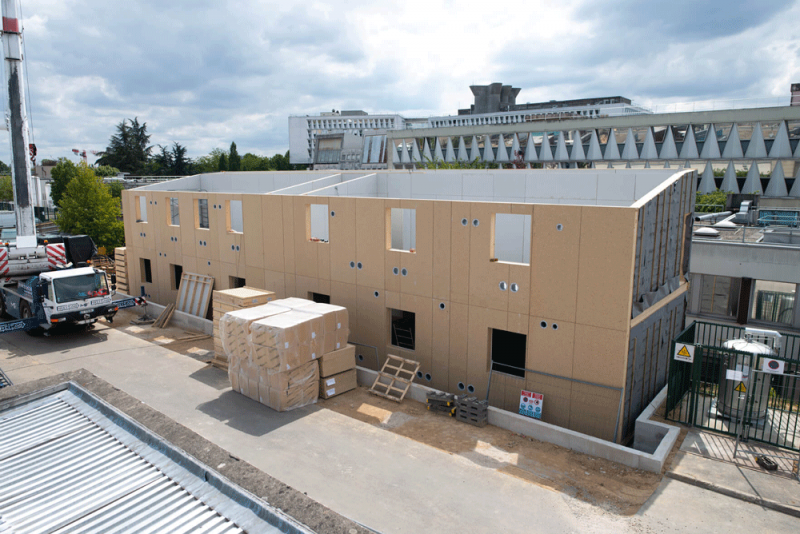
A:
113 309 668 515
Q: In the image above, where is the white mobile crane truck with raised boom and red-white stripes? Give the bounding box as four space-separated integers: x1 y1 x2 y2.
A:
0 0 144 333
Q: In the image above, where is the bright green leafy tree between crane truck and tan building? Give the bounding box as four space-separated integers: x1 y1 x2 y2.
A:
56 163 125 249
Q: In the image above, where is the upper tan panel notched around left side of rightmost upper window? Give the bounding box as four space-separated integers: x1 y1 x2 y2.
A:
469 202 511 312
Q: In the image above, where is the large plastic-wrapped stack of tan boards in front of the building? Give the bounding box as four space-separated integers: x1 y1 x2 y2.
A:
219 298 355 411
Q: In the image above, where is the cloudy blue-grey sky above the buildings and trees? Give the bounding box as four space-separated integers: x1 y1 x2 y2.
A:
0 0 800 161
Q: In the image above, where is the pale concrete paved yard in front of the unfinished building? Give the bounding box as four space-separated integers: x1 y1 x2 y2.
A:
0 320 796 534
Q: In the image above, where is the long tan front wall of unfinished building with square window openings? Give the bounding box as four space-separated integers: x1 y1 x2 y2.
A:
126 192 635 442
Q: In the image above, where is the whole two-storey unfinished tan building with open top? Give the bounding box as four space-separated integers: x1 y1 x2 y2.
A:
123 169 696 442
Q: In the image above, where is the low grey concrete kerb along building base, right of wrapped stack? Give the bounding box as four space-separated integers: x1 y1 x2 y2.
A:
357 367 680 473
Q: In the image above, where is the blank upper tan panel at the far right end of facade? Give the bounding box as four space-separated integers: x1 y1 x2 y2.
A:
575 206 636 332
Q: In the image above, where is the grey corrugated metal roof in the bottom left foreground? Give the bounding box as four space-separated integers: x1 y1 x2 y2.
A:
0 391 312 534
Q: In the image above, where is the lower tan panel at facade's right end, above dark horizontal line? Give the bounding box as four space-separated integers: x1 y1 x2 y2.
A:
572 324 628 388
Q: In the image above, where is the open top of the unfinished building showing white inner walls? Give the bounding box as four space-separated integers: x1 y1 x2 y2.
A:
136 169 690 207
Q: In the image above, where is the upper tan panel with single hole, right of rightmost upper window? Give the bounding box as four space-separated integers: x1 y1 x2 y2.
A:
529 204 583 323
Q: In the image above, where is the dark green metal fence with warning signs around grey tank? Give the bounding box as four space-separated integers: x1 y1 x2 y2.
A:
665 321 800 451
